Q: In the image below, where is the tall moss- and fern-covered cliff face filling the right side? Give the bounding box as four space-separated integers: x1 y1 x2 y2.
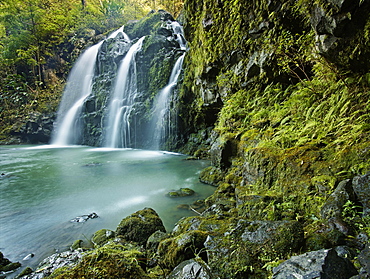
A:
171 0 370 278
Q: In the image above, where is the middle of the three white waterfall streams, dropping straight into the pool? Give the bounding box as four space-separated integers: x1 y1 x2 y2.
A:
105 37 145 148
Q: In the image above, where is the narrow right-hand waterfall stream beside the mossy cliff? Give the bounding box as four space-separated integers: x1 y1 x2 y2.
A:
152 53 185 149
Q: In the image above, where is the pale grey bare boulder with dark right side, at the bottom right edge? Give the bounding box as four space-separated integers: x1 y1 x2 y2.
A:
272 249 357 279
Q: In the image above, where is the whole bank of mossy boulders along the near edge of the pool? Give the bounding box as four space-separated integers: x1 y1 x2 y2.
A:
2 173 370 279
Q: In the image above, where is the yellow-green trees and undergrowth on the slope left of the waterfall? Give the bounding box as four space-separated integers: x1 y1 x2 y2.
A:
0 0 151 140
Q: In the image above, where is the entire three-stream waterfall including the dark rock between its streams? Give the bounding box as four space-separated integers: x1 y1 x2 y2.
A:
51 14 187 149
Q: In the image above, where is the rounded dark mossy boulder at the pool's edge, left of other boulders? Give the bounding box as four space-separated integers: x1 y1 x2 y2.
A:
116 208 166 244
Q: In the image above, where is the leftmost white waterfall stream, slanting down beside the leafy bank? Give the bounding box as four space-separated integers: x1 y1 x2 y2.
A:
52 42 103 146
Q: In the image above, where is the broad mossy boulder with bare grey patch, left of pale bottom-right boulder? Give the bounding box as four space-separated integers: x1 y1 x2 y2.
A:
204 219 303 278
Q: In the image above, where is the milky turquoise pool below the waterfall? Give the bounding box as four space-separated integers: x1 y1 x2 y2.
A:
0 146 214 276
